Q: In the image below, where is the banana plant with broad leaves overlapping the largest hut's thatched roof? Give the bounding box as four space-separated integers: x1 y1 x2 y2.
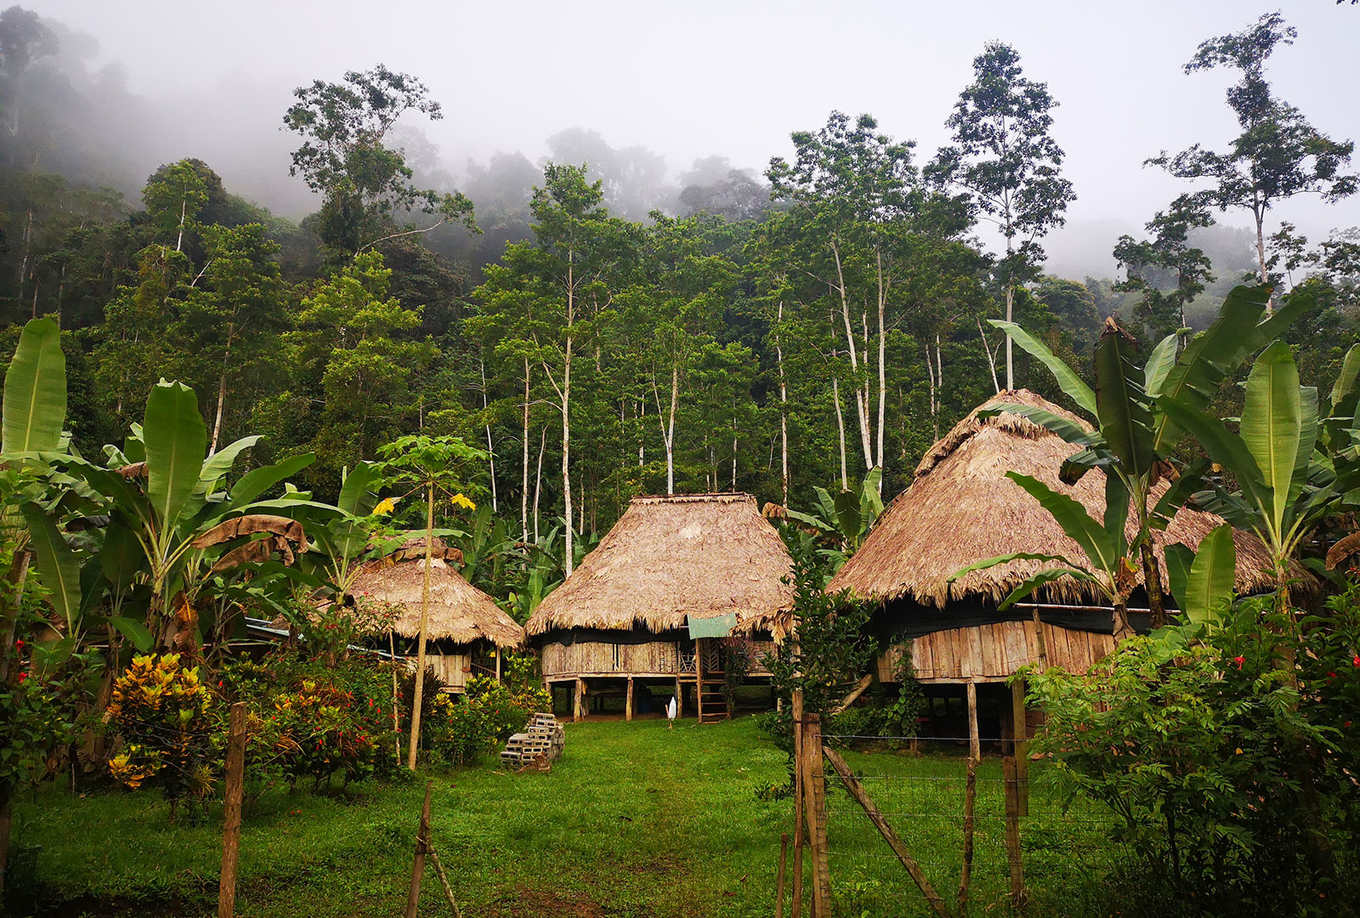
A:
993 287 1311 626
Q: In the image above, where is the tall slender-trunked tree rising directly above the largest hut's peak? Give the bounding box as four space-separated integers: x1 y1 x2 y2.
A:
930 42 1076 389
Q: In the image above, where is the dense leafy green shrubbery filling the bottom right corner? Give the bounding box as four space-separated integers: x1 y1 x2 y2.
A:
1025 590 1360 915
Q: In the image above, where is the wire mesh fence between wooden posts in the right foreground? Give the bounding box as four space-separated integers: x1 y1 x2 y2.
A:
824 734 1129 917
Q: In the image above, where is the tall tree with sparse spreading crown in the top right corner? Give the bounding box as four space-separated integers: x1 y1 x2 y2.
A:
1148 12 1357 295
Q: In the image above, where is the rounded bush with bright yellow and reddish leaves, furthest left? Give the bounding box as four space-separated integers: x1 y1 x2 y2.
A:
109 653 218 819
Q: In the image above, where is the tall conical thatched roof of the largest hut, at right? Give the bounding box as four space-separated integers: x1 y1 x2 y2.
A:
828 389 1273 605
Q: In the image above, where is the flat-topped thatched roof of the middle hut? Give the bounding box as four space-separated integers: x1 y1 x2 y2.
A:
525 494 793 639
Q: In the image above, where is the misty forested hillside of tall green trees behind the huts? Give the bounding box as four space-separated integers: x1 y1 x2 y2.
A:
0 7 1360 552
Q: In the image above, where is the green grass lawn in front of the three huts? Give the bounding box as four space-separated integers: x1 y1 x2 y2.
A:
14 718 1115 918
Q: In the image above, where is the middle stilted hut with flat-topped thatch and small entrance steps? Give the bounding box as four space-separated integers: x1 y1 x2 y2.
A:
525 494 793 722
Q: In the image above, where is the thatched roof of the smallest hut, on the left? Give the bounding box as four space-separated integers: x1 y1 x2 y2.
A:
350 545 524 647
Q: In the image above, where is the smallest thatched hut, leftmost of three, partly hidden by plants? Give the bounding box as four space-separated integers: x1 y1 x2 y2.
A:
350 543 524 692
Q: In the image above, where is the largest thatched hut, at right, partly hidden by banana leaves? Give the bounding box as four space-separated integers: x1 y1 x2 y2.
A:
828 389 1272 745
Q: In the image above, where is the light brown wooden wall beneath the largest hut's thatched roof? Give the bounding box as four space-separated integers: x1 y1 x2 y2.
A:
879 622 1114 681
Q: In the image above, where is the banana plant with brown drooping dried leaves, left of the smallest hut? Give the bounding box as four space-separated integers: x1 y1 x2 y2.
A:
24 381 337 647
